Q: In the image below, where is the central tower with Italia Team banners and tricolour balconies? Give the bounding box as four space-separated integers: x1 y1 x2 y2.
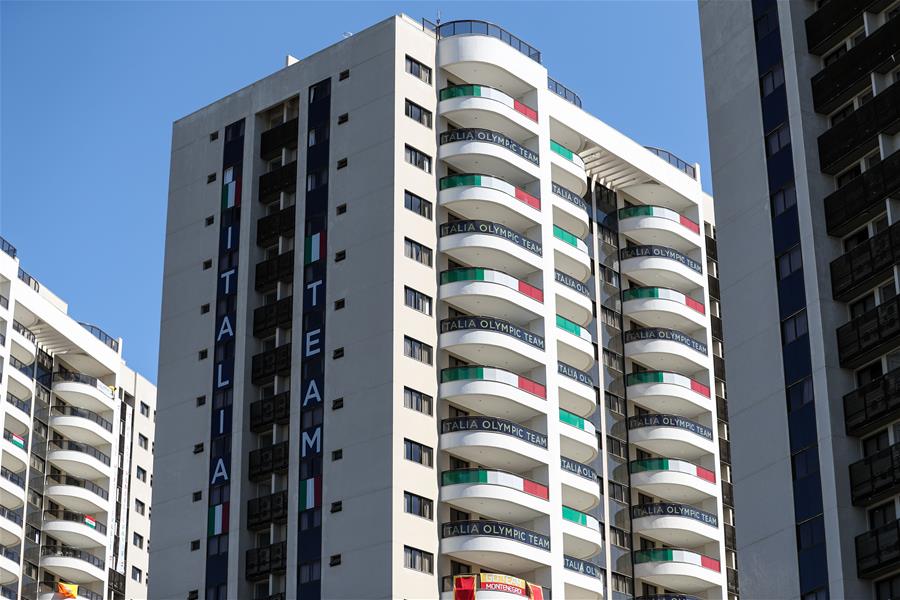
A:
156 15 737 600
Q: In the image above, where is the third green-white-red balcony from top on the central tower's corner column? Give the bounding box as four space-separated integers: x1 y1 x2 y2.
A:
440 267 544 323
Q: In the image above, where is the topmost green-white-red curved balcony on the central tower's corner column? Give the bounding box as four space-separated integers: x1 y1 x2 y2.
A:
438 84 540 140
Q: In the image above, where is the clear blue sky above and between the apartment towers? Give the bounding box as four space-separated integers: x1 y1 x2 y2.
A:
0 0 710 381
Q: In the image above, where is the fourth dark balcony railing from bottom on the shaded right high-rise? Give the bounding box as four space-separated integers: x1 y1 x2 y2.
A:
837 296 900 369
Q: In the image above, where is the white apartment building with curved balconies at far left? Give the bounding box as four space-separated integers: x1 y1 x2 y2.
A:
0 238 156 600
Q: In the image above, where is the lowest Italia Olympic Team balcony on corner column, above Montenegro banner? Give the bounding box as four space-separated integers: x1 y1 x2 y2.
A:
441 521 552 573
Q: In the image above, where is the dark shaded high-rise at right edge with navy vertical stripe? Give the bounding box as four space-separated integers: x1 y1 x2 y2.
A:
700 0 900 600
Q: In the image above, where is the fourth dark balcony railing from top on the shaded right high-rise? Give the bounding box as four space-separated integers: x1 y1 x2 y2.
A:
824 150 900 236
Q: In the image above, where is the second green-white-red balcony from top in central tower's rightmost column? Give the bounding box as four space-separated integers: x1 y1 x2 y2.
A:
622 287 707 330
